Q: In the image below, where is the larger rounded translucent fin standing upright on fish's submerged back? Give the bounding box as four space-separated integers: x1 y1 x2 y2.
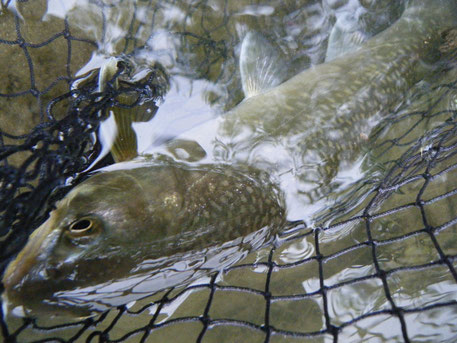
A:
240 32 287 98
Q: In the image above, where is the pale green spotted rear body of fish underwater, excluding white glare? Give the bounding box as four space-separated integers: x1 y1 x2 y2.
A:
218 1 457 160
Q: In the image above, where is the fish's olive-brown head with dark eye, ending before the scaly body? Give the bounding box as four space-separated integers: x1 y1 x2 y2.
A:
2 168 187 316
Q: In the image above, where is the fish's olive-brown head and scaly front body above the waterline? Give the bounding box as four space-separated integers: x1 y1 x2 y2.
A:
3 165 284 313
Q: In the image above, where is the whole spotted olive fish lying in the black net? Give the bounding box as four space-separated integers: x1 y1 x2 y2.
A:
3 0 457 318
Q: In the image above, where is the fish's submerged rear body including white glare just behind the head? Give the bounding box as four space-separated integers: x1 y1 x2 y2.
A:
169 0 457 215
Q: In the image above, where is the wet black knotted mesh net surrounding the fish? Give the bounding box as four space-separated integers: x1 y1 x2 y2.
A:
0 1 457 342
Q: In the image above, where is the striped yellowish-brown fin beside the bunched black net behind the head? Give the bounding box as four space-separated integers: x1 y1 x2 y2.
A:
98 57 158 162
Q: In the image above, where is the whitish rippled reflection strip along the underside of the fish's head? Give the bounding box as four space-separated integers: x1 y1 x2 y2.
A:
20 229 271 319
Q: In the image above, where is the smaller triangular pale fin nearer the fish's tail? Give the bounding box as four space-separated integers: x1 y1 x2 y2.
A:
325 20 369 62
